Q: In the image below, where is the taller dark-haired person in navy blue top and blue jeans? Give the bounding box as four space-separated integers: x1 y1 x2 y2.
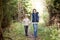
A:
32 9 39 38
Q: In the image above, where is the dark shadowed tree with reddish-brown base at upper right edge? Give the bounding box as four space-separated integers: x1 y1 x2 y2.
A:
47 0 60 27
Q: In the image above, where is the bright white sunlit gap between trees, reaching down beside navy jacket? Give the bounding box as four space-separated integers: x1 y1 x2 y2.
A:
31 0 48 23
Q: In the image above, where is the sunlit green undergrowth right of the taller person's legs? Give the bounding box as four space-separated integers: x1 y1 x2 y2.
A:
38 25 60 40
